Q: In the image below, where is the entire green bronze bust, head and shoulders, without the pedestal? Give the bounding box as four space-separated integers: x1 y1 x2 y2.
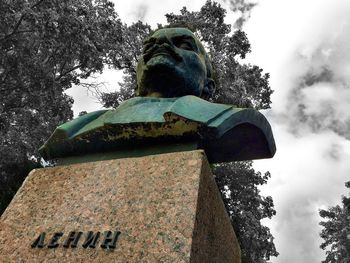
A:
40 28 276 162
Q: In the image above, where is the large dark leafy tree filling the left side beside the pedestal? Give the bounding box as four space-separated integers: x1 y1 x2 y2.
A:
0 0 122 213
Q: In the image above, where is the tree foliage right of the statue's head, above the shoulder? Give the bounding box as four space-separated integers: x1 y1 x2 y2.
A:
166 1 272 109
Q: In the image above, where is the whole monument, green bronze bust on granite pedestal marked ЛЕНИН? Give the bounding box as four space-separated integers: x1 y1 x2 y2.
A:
0 28 275 263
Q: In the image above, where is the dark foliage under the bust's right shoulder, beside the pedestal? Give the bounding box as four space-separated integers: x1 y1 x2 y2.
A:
213 161 278 263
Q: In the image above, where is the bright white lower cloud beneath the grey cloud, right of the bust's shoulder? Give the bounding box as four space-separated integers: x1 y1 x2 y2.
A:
255 128 350 263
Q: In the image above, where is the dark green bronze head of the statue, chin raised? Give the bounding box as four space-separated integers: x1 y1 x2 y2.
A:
136 28 215 99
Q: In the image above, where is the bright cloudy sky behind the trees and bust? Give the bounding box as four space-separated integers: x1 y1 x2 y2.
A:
68 0 350 263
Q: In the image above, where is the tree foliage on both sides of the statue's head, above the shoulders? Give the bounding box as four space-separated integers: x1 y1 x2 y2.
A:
101 1 272 109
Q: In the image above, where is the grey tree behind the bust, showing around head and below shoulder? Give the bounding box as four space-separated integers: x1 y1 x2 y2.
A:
100 1 278 263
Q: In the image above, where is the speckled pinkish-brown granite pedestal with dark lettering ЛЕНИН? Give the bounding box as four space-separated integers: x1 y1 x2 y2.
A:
0 150 240 263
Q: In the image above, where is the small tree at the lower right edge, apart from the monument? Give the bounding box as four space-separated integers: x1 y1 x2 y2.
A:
319 181 350 263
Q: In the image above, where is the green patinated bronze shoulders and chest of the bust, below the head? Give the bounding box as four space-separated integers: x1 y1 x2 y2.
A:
39 95 276 162
